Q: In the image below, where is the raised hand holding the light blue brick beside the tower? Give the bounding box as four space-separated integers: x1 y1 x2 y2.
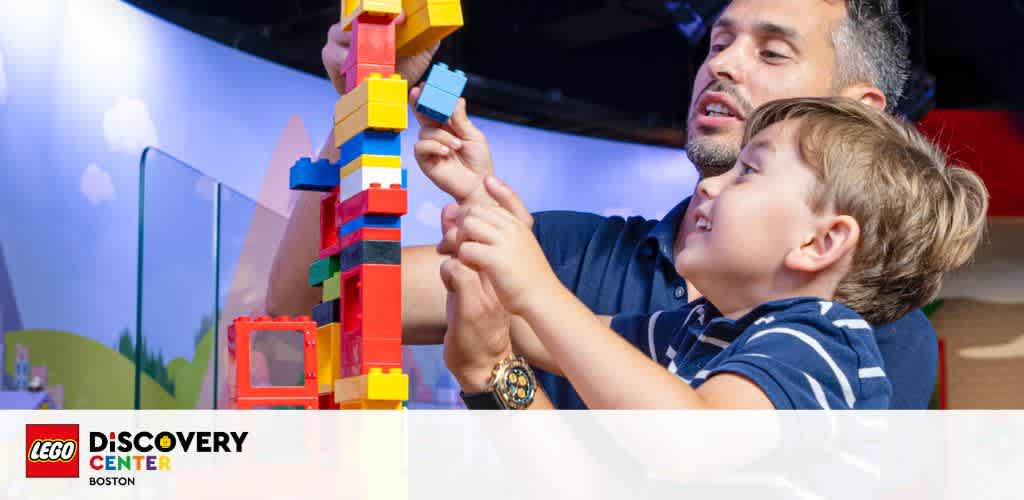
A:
410 87 494 205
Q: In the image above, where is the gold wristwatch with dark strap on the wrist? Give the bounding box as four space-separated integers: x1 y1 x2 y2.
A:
460 355 537 410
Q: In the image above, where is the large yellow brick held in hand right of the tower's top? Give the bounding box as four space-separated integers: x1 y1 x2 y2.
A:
395 0 463 55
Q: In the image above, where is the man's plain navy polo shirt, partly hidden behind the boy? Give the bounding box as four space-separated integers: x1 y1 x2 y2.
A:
534 198 938 410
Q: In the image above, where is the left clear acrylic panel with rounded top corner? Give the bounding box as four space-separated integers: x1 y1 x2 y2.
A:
134 148 217 409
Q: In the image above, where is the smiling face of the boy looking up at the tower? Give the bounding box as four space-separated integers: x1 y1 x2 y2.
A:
676 120 817 301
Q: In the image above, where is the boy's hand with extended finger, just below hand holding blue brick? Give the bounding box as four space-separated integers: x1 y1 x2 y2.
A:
457 176 561 315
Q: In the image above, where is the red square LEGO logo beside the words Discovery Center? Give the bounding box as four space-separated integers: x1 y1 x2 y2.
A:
25 423 79 477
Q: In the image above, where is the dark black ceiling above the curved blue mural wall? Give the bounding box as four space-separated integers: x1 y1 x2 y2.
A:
123 0 1024 145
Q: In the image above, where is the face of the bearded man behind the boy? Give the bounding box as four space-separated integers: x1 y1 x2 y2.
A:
686 0 846 177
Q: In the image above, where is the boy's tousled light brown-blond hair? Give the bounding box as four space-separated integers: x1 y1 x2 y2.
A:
743 97 988 325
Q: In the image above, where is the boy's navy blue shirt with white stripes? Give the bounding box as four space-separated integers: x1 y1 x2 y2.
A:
611 297 892 410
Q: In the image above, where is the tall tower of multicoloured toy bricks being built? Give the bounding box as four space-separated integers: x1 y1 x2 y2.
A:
290 0 465 410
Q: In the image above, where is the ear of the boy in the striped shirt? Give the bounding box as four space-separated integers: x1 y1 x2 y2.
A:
785 215 860 273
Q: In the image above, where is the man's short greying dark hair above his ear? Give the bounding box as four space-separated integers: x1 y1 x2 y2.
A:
833 0 910 112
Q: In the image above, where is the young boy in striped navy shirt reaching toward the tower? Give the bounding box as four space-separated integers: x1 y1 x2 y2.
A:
430 98 987 409
